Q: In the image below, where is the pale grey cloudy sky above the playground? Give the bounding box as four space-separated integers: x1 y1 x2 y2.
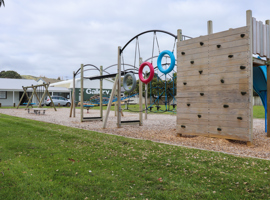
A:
0 0 270 80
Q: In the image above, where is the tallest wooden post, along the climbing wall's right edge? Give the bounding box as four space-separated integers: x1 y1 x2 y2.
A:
246 10 253 142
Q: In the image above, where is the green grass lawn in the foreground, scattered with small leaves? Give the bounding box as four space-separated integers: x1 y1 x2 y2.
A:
0 114 270 200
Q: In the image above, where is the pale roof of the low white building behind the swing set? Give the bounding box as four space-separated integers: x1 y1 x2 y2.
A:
0 78 70 92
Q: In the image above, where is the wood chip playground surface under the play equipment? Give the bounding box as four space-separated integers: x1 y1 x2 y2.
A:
0 108 270 160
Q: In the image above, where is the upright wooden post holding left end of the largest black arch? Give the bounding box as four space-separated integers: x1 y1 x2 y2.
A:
117 46 121 128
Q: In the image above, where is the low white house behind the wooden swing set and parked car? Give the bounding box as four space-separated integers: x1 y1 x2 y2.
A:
0 78 71 106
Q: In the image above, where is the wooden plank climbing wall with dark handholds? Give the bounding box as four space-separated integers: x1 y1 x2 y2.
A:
177 27 253 141
